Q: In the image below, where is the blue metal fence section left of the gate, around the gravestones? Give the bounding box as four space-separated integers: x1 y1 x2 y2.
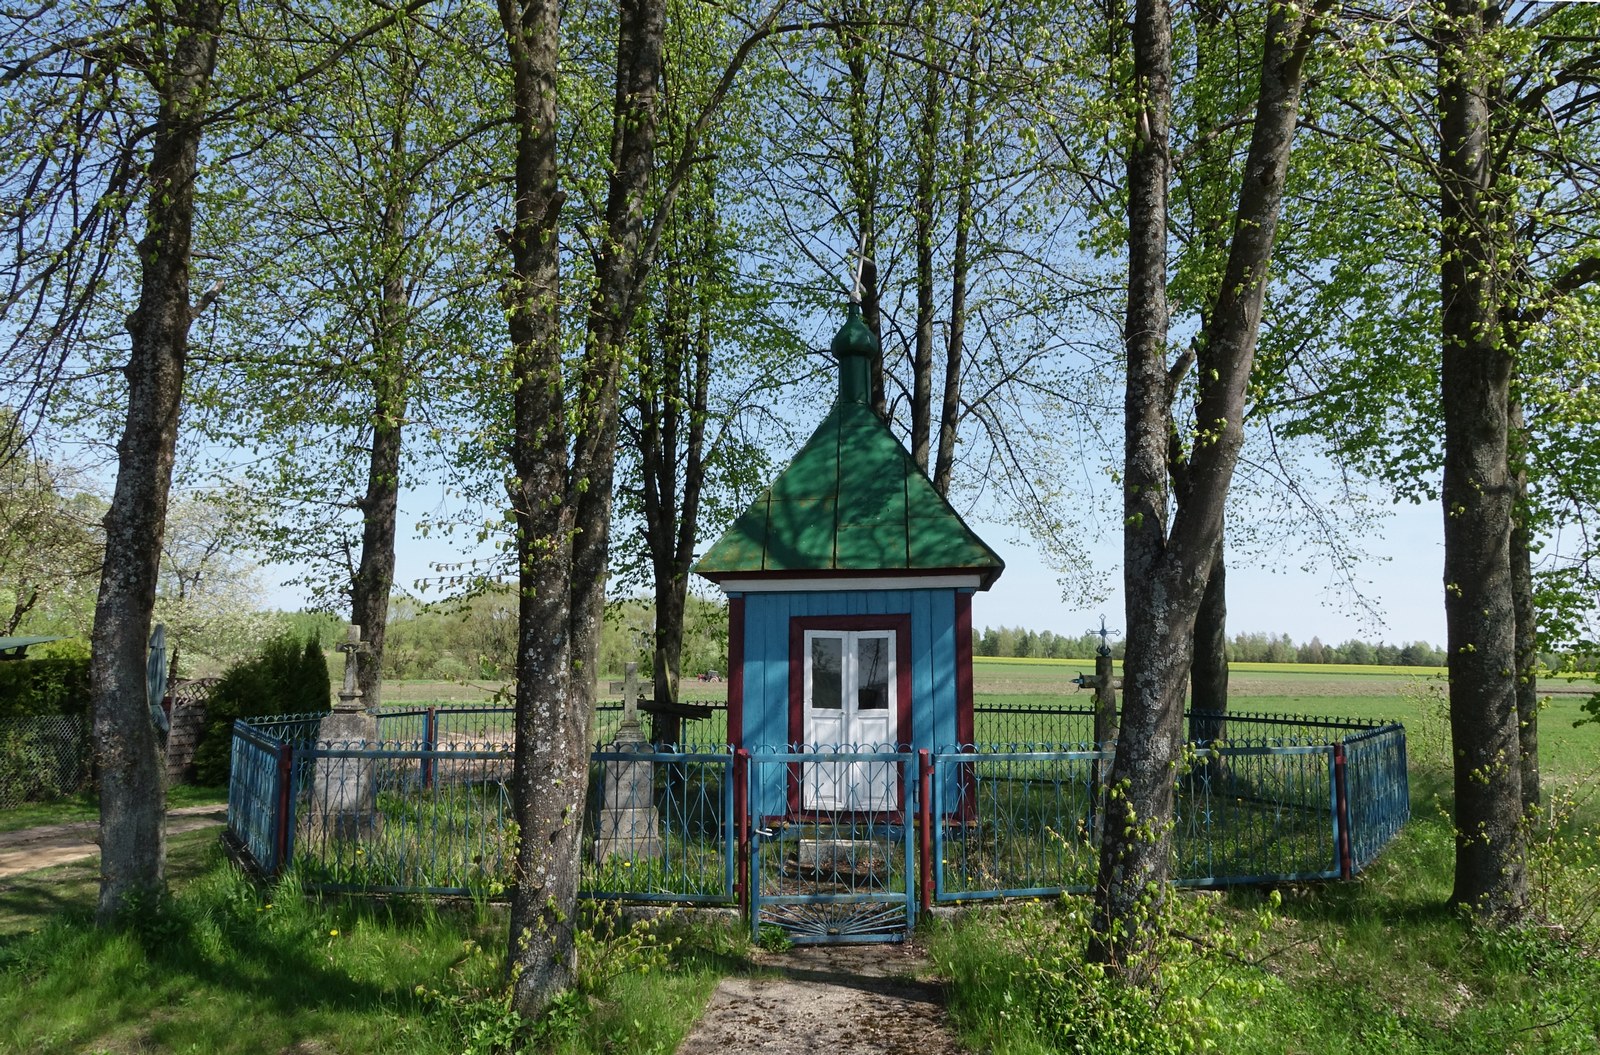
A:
229 716 736 903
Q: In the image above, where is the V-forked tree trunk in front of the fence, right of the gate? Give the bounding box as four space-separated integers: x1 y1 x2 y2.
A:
1090 0 1326 983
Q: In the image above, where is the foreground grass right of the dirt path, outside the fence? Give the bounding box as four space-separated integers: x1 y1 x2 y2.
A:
928 797 1600 1055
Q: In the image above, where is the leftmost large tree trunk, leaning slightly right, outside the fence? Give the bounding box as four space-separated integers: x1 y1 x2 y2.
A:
90 0 224 924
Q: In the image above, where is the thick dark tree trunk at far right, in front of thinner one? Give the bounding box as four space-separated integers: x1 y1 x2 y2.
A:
1438 0 1526 921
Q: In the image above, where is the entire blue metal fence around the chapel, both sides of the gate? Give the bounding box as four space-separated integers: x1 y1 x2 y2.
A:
229 708 1410 903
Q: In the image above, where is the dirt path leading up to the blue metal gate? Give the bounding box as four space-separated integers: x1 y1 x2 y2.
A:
677 945 965 1055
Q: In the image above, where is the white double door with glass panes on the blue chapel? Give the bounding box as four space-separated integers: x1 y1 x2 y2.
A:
800 631 899 810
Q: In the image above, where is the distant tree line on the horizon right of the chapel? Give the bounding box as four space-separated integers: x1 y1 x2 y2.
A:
973 626 1445 666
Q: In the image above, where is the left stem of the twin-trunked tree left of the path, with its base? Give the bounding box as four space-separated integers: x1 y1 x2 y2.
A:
499 0 589 1018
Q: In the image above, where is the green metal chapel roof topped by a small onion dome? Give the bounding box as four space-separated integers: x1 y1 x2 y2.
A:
694 311 1005 589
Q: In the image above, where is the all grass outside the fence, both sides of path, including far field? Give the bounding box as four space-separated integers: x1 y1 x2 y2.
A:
0 663 1600 1055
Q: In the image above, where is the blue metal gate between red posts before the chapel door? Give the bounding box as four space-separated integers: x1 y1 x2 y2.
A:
746 746 917 945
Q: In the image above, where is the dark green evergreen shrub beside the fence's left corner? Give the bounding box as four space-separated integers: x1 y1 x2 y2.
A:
194 634 330 786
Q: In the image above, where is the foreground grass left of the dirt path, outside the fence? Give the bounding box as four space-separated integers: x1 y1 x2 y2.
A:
0 832 749 1055
